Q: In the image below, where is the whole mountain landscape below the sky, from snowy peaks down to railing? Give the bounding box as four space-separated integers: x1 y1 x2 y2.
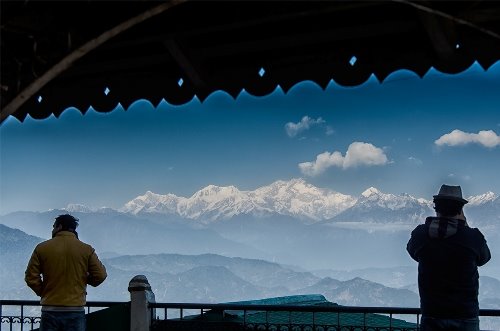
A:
0 180 500 309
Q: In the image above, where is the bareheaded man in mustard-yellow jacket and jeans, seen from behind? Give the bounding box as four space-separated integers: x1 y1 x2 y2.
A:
25 214 107 331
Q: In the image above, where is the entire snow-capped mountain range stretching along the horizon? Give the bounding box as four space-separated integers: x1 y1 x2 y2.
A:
65 179 500 223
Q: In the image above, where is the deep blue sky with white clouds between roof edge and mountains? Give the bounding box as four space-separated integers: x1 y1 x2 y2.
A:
0 63 500 214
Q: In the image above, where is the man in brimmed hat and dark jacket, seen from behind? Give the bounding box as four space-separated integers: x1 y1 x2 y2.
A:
406 185 491 331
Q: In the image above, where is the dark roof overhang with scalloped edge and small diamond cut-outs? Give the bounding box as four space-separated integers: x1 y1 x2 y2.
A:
0 0 500 123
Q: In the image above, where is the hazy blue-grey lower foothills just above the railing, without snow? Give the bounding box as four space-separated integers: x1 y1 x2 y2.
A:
0 225 500 309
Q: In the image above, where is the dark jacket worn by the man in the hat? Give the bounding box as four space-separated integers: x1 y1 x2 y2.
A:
406 217 491 318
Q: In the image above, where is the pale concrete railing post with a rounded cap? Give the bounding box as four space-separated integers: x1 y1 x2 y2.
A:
128 275 155 331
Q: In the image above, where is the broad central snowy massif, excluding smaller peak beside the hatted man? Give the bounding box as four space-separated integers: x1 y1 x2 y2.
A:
122 179 356 222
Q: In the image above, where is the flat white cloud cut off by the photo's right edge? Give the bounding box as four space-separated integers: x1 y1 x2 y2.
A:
434 130 500 148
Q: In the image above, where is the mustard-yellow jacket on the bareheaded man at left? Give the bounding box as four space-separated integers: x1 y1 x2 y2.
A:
24 231 107 307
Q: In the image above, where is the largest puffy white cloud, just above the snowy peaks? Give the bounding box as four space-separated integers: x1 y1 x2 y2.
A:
299 141 388 176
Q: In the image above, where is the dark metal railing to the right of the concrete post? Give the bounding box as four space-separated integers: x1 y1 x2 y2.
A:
149 303 500 331
